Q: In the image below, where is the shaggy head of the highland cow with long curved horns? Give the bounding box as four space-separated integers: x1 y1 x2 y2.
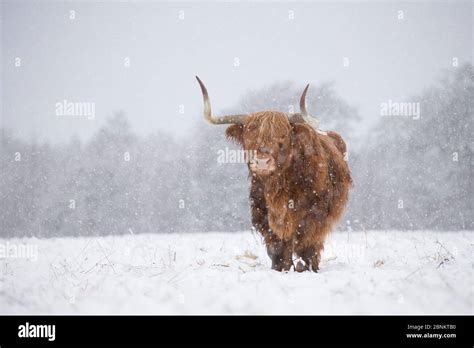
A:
196 76 317 176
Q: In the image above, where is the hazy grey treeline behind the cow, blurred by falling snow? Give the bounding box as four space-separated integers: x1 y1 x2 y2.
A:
0 65 474 237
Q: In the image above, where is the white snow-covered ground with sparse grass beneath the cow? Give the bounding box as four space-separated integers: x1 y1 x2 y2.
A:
0 231 474 314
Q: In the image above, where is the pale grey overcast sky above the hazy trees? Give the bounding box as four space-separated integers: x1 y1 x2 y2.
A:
1 1 472 142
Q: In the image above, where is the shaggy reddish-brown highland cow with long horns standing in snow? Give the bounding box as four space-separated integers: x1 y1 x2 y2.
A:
196 76 352 272
